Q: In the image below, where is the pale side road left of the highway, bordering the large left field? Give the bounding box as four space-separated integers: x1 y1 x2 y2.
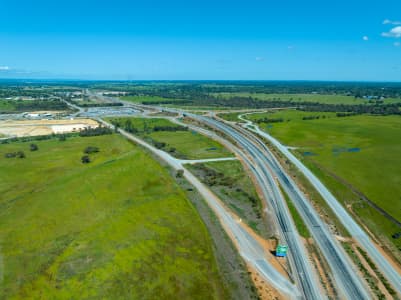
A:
97 118 302 299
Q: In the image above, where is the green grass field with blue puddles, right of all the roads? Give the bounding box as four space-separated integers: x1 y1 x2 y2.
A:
248 110 401 252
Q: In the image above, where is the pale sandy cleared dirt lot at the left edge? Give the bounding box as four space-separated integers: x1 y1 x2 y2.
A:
0 119 99 137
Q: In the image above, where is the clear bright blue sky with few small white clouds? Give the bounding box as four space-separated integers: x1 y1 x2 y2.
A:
0 0 401 81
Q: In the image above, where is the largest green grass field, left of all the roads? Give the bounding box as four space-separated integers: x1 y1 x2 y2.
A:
0 134 227 299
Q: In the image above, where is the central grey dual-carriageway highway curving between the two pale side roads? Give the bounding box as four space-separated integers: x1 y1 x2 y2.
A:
180 113 370 299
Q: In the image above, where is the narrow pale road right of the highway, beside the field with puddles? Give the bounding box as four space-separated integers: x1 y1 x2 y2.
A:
241 113 401 294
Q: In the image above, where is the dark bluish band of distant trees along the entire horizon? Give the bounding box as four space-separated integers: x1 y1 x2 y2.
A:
0 80 401 100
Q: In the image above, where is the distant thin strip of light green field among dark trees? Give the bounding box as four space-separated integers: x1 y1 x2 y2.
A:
213 92 401 104
